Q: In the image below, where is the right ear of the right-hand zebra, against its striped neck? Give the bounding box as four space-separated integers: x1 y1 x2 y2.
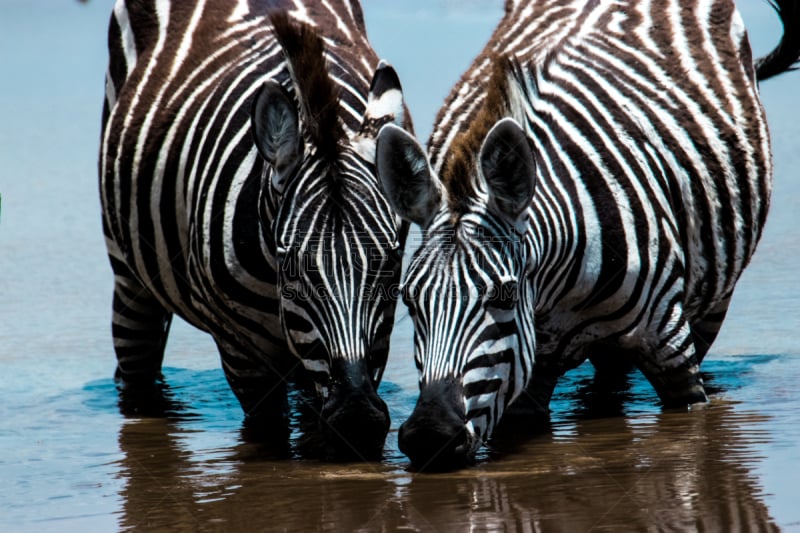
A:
480 118 536 223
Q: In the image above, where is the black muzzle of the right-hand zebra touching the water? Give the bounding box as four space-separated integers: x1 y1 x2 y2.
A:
398 380 471 471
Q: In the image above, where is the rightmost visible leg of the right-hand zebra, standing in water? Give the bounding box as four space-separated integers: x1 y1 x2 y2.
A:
632 308 708 407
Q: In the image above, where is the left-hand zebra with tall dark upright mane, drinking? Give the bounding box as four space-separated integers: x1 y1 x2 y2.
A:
99 0 411 456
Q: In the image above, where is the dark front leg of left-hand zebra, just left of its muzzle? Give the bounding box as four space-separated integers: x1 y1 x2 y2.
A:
217 341 291 442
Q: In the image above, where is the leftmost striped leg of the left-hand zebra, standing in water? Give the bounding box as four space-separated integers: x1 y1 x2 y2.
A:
111 258 172 389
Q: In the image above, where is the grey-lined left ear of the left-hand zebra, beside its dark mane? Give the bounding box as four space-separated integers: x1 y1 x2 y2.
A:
250 81 303 191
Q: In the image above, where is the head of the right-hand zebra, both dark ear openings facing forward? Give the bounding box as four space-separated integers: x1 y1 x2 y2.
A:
377 118 535 468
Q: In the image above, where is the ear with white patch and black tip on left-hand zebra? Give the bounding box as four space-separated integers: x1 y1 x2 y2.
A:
353 60 406 161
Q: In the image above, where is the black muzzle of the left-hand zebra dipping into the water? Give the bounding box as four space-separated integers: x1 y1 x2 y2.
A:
320 359 390 460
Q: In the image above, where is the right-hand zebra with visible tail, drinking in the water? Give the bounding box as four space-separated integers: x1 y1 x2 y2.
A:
377 0 800 466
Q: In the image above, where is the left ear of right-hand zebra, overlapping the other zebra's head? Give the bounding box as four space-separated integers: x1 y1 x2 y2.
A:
375 124 442 228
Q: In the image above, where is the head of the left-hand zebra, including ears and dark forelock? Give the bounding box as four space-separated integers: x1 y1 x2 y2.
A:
252 16 407 457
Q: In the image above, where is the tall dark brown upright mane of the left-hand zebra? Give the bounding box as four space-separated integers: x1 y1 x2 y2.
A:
269 11 345 162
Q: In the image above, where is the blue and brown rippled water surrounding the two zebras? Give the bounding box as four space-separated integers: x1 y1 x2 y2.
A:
0 0 800 531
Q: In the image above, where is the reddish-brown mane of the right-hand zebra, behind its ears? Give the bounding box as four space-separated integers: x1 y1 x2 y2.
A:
441 56 514 217
